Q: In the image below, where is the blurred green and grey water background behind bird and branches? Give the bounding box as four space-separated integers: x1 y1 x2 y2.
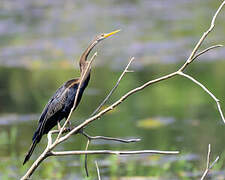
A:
0 0 225 180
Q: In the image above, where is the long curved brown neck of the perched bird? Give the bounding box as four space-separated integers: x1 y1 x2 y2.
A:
79 39 98 76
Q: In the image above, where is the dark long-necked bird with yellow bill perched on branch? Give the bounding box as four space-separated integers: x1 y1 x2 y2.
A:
23 30 120 165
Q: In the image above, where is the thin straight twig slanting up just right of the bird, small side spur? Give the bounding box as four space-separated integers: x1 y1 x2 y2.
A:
90 57 134 117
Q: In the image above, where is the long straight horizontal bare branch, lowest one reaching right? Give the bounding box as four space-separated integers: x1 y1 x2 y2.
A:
49 150 179 156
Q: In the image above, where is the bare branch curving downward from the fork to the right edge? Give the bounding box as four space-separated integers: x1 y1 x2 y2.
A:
178 72 225 123
